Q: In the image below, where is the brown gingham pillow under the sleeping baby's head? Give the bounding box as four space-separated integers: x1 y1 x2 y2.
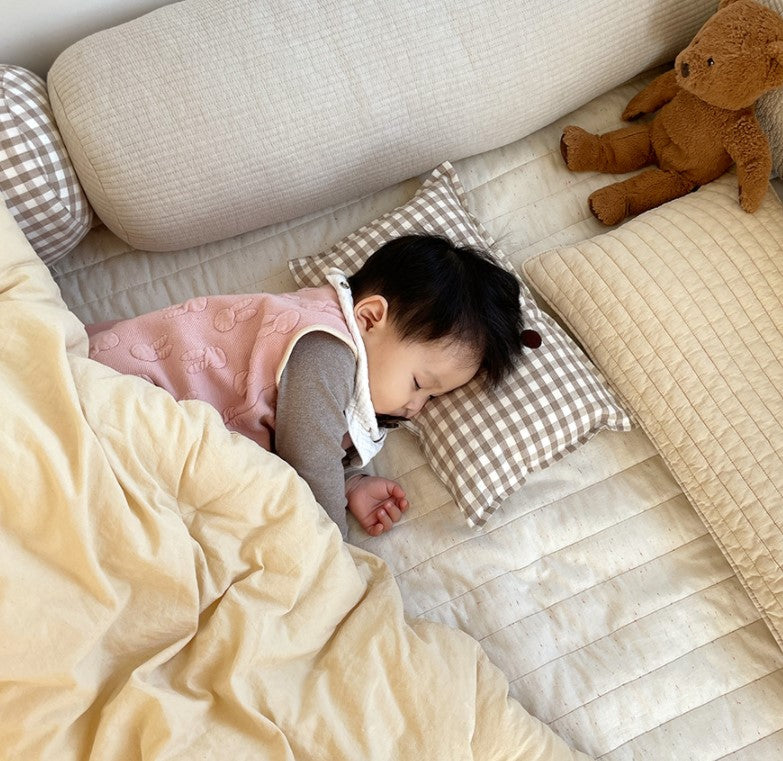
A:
289 163 631 526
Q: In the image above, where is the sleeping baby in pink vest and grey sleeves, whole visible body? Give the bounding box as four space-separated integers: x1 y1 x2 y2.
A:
87 235 530 537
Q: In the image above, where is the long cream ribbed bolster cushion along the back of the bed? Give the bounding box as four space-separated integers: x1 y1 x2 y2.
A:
48 0 715 251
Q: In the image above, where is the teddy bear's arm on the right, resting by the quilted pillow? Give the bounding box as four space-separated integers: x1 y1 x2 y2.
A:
725 113 772 213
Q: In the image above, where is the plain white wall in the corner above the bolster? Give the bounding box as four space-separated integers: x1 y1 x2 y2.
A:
0 0 178 77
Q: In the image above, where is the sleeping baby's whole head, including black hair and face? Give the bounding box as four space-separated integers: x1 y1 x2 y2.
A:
348 235 522 418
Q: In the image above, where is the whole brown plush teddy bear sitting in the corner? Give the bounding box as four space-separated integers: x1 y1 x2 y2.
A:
560 0 783 225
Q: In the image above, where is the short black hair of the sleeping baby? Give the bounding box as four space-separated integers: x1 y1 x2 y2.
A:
348 235 523 385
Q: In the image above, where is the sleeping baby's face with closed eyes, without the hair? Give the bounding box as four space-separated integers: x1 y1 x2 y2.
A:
364 322 478 418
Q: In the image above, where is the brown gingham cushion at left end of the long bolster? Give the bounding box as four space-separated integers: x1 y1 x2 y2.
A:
0 66 93 264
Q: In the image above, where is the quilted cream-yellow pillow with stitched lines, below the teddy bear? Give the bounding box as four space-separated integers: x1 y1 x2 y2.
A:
524 175 783 646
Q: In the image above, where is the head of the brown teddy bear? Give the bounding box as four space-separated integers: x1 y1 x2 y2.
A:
674 0 783 110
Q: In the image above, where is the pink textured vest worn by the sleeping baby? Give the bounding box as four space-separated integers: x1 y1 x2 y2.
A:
90 285 356 450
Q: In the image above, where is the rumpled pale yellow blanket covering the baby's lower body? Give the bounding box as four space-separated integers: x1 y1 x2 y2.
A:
0 199 586 761
